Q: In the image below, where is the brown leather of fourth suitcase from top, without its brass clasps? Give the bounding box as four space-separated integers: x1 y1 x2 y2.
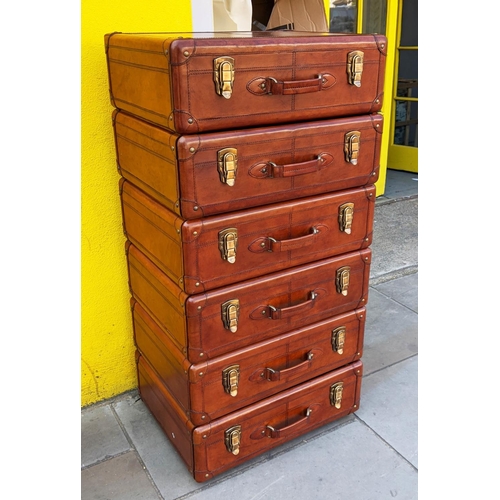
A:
127 241 371 363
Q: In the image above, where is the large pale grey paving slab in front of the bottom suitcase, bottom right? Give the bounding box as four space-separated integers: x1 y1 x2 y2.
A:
182 420 418 500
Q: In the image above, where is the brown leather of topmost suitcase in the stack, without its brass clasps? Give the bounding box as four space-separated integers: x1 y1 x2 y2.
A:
105 31 387 134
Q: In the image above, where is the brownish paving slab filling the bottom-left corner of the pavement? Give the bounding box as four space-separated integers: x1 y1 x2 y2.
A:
81 451 161 500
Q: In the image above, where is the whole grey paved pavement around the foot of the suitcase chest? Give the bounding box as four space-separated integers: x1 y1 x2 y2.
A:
81 171 418 500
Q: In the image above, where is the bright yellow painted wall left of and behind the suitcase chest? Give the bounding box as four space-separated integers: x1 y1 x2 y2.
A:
81 0 192 407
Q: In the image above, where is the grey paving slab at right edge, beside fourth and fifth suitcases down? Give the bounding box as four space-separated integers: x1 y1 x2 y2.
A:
362 288 418 376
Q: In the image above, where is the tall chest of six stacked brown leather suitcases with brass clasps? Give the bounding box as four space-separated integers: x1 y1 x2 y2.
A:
105 32 386 482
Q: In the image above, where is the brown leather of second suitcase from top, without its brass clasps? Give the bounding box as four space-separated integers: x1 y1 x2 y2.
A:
113 110 383 219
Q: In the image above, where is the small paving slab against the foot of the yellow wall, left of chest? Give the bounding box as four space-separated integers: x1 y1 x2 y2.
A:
81 405 130 467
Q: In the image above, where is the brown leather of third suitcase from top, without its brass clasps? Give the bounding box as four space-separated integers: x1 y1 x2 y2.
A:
121 181 375 294
